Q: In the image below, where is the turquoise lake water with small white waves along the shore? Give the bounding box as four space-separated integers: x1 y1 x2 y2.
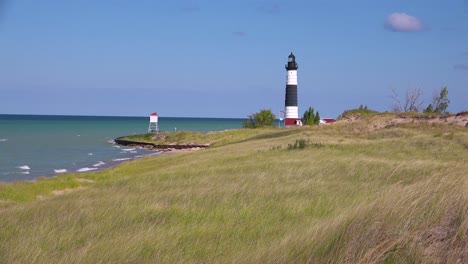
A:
0 115 243 182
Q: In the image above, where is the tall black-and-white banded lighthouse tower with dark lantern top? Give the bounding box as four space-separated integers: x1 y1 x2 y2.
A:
284 52 301 126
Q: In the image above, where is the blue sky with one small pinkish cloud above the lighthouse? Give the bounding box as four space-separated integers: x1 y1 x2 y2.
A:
0 0 468 118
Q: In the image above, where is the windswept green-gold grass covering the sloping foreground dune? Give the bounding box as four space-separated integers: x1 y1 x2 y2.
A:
0 119 468 263
